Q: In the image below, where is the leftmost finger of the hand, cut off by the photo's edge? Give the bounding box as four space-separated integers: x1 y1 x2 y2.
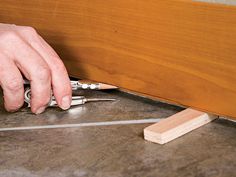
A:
0 53 24 112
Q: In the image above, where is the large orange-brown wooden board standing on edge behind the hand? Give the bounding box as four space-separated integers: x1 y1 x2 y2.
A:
0 0 236 118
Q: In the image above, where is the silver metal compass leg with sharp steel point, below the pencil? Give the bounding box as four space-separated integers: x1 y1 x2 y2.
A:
24 88 115 107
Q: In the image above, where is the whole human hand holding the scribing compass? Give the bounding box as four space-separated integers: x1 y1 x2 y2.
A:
0 23 72 114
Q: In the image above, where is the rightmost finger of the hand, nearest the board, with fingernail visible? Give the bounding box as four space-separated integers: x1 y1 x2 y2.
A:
19 27 72 109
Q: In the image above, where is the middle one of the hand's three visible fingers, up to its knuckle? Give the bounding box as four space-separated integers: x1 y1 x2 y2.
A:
0 33 51 114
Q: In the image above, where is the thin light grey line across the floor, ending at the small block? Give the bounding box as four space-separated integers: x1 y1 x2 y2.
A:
0 118 162 132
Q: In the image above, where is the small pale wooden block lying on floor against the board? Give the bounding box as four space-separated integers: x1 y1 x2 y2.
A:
144 108 217 144
